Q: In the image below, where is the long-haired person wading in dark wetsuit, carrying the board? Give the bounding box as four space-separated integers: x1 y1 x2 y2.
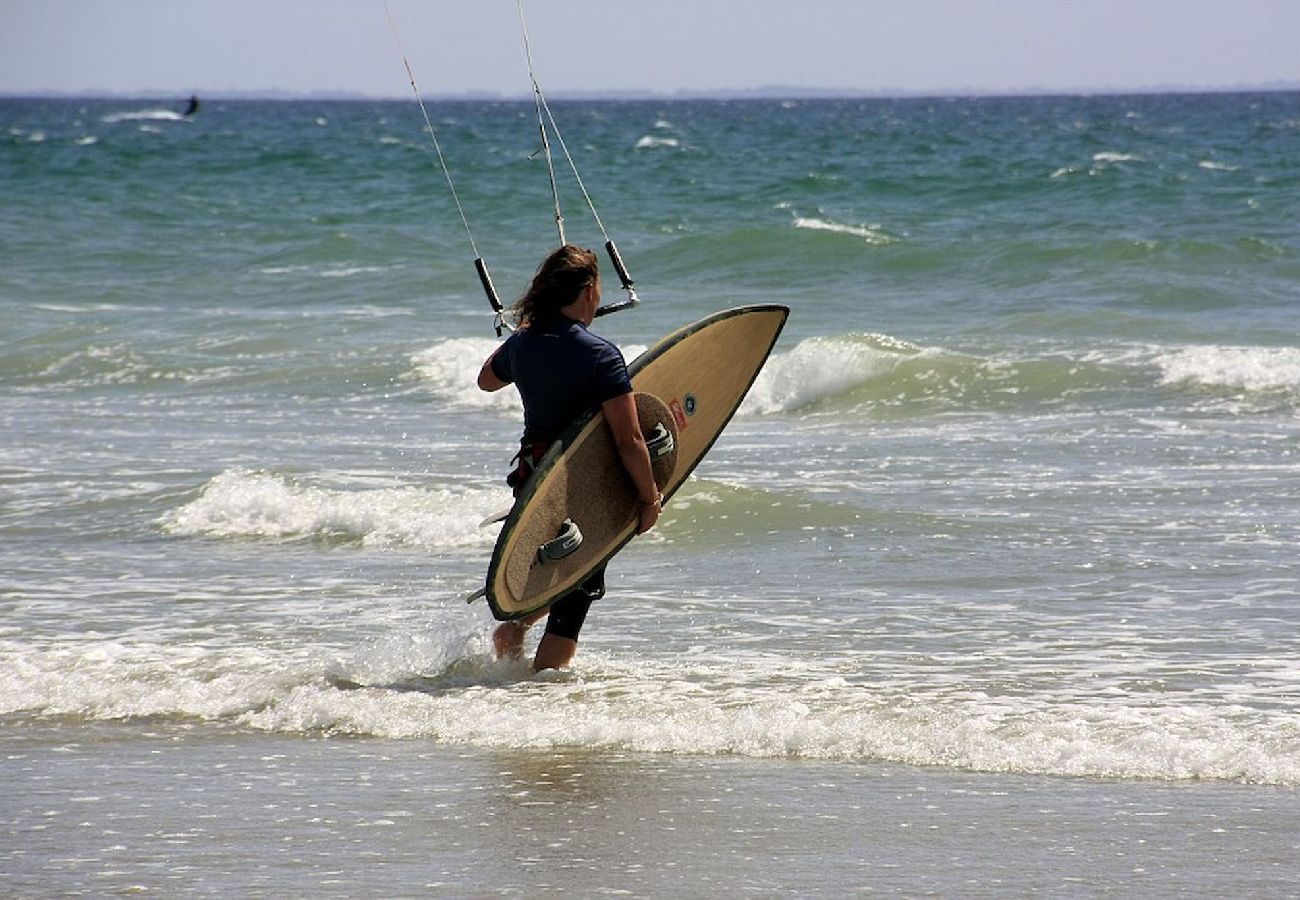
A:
478 245 663 671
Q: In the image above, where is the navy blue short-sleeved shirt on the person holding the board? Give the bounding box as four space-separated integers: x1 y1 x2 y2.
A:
491 316 632 443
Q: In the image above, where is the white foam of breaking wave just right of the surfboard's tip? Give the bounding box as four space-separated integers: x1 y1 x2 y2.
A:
740 334 922 415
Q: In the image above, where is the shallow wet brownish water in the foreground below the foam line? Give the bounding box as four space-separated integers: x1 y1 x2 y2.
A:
4 722 1300 896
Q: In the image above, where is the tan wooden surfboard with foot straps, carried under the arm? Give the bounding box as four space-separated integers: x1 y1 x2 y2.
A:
471 304 789 620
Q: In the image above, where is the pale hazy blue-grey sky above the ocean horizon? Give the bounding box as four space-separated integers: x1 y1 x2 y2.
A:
0 0 1300 96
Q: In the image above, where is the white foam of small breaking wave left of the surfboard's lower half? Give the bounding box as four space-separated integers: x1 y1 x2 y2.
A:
164 470 510 549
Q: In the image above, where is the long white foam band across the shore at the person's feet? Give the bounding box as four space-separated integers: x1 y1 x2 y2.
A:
0 639 1300 786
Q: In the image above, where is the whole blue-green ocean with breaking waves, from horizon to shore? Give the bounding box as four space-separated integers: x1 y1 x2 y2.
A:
0 92 1300 896
